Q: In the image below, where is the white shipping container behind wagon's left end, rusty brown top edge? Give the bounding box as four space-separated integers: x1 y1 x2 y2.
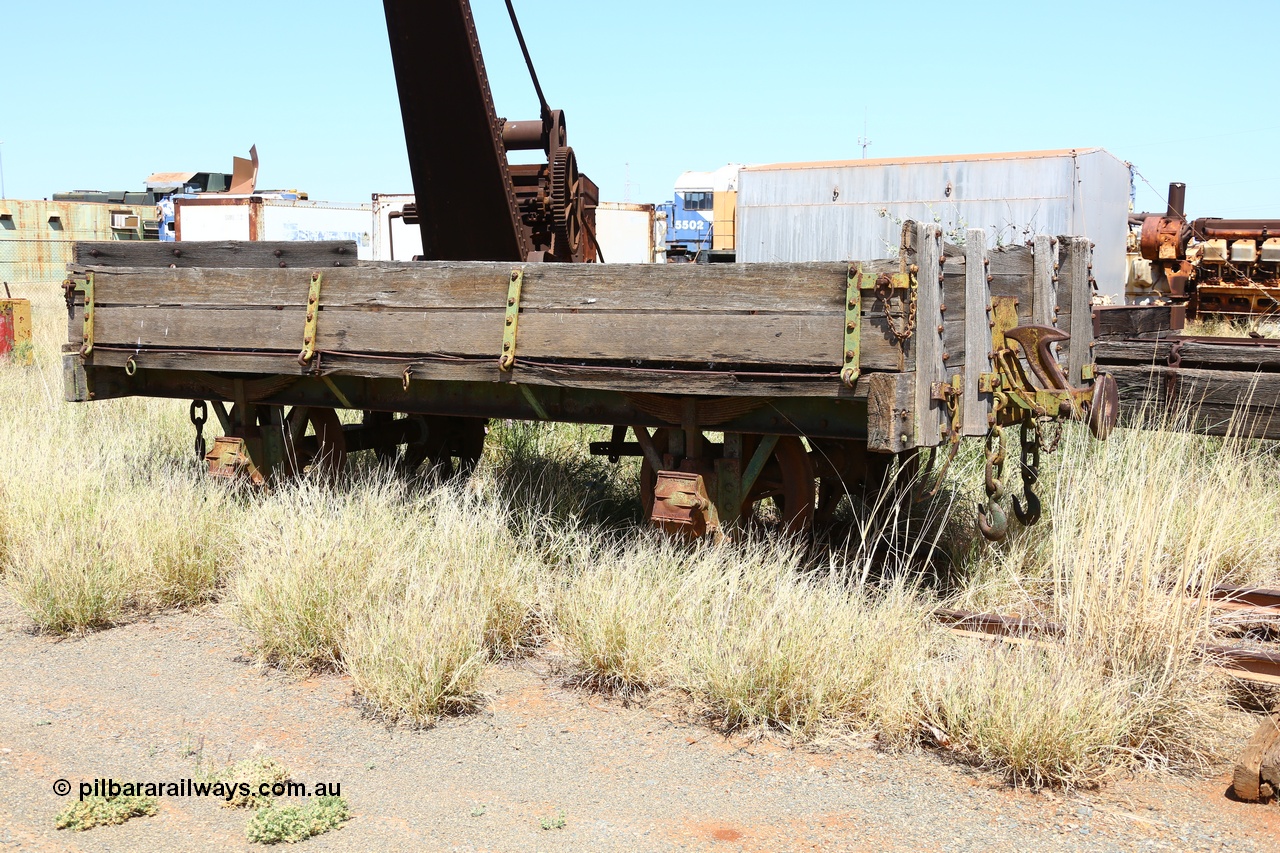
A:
174 193 374 260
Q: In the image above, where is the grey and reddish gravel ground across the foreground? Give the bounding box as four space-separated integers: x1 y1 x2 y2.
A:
0 591 1280 852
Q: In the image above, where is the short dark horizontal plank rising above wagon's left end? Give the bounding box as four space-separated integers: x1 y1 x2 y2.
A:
74 240 357 268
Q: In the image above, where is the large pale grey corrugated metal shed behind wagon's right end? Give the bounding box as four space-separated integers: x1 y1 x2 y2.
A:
736 149 1133 301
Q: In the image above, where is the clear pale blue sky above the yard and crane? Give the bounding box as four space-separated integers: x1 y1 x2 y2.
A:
0 0 1280 216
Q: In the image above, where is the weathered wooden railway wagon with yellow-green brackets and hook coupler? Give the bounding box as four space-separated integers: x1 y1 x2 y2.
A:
64 223 1114 533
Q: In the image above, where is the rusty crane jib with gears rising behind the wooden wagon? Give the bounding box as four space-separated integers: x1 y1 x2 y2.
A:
383 0 599 261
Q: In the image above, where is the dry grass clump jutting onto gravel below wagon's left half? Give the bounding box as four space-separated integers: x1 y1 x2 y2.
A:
229 474 539 724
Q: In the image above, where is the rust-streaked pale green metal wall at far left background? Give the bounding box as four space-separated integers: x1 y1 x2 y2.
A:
0 199 156 306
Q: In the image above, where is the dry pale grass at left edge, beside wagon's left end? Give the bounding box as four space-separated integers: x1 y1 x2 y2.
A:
0 302 236 631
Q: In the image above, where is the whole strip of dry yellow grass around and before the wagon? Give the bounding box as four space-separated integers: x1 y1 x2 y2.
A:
0 298 1280 785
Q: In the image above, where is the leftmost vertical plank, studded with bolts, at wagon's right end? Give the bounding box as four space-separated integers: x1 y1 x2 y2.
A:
914 219 947 447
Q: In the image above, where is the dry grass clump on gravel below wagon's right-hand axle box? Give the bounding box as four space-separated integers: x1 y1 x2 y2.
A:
556 537 941 743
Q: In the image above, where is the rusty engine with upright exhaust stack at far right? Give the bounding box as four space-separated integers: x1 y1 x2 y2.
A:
1135 183 1280 318
